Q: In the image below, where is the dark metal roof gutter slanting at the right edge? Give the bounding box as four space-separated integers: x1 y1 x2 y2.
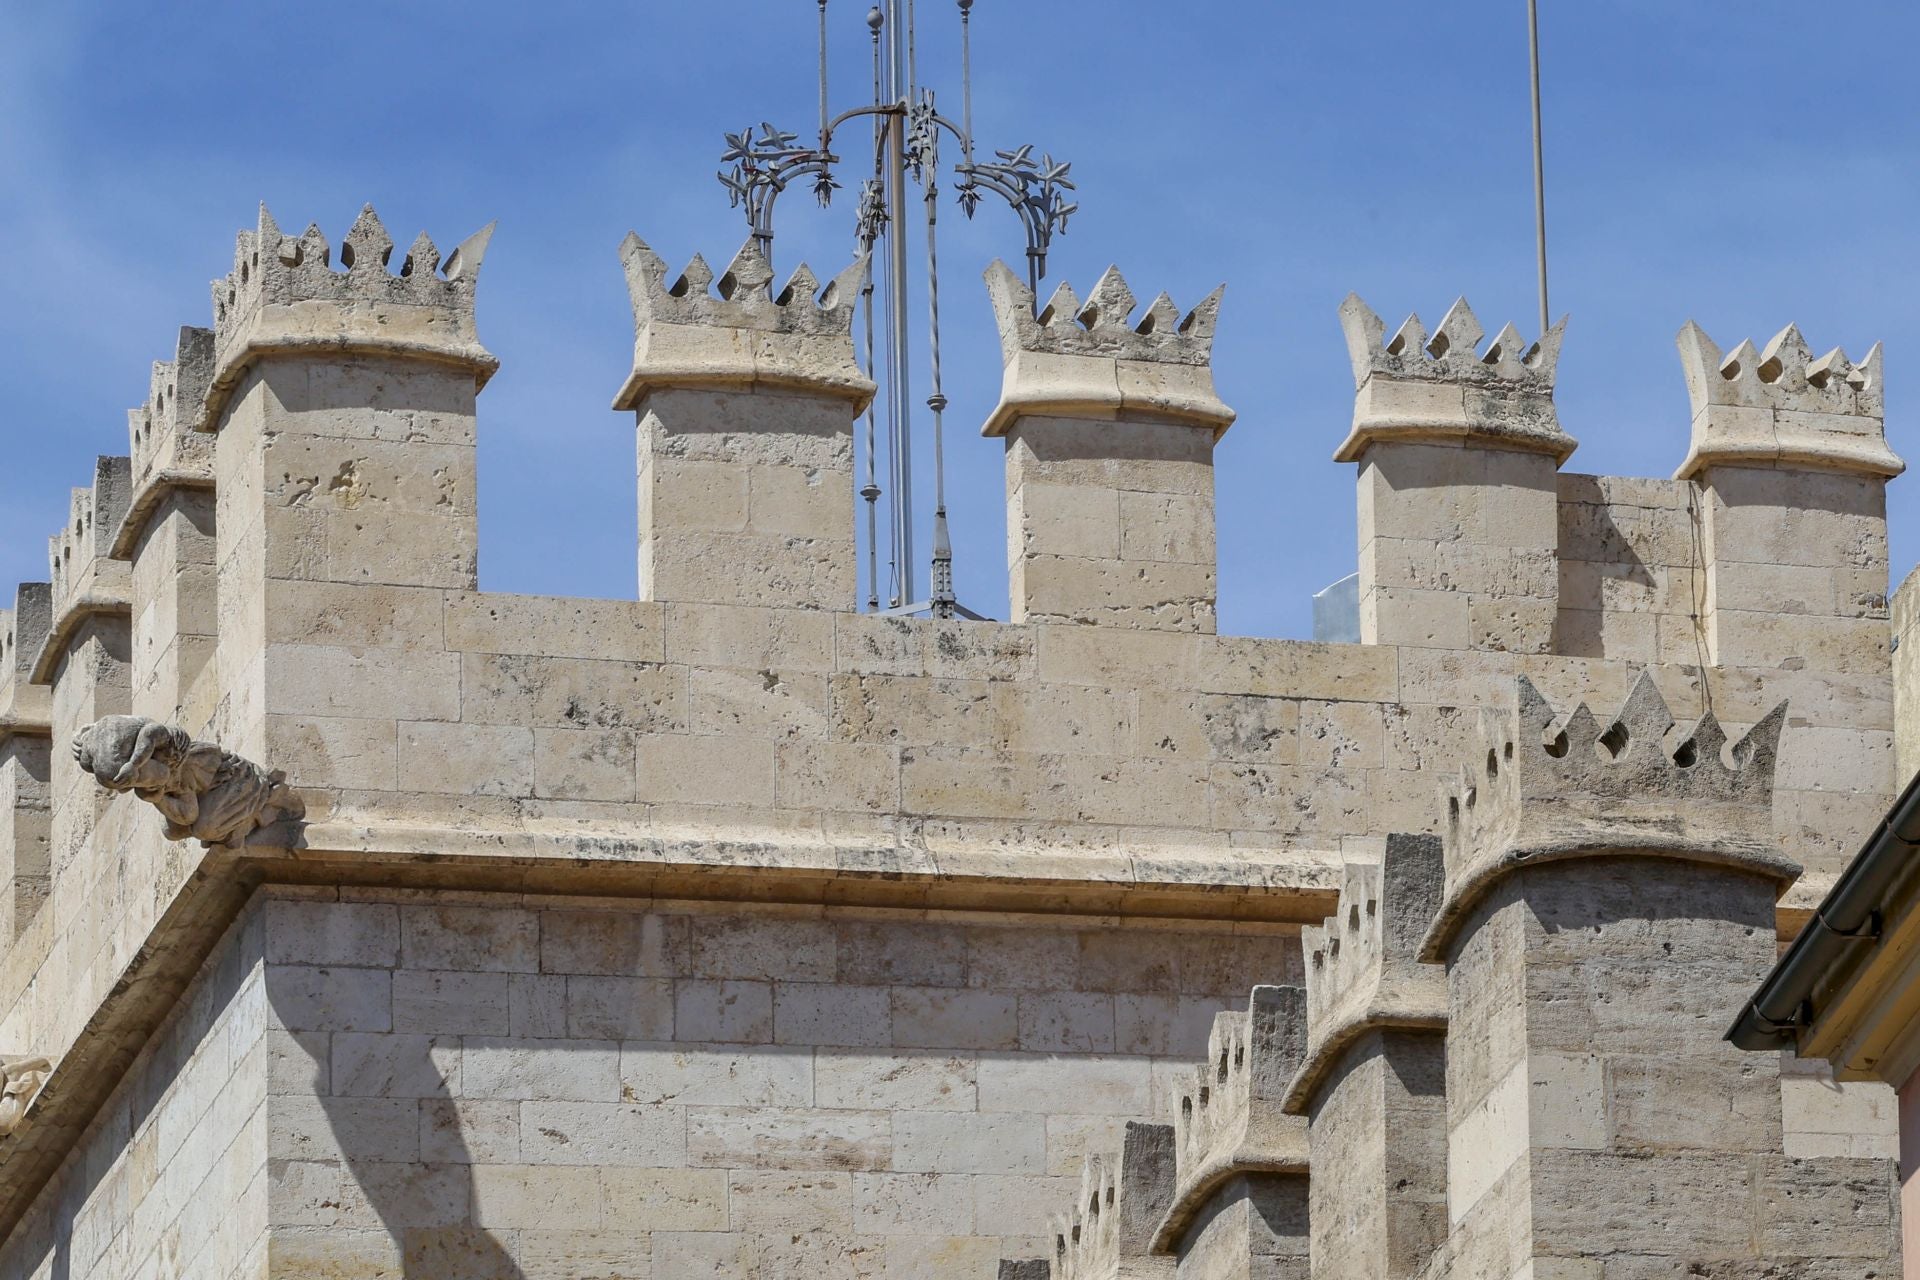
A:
1726 775 1920 1050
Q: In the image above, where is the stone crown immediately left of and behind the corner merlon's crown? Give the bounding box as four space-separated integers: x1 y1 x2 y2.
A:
109 326 213 560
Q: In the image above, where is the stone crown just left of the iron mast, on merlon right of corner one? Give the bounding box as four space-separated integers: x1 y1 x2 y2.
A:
612 232 874 413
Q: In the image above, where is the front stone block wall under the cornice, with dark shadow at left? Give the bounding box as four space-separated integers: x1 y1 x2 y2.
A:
263 889 1300 1280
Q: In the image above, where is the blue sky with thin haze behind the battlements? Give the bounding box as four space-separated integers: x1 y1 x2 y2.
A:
0 0 1920 635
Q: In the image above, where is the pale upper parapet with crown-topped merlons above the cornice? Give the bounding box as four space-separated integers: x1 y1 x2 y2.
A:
0 202 1897 1274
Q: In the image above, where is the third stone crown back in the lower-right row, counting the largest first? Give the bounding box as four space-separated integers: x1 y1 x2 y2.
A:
1154 986 1308 1251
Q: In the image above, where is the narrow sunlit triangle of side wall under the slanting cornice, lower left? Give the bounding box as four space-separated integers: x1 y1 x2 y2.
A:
0 912 271 1280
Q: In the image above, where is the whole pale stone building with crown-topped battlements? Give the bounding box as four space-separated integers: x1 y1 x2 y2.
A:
0 200 1920 1280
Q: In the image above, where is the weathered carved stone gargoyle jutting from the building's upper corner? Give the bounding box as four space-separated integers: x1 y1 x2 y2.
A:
73 716 305 844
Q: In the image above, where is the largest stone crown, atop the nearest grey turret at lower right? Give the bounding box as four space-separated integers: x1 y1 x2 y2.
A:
1421 672 1801 961
